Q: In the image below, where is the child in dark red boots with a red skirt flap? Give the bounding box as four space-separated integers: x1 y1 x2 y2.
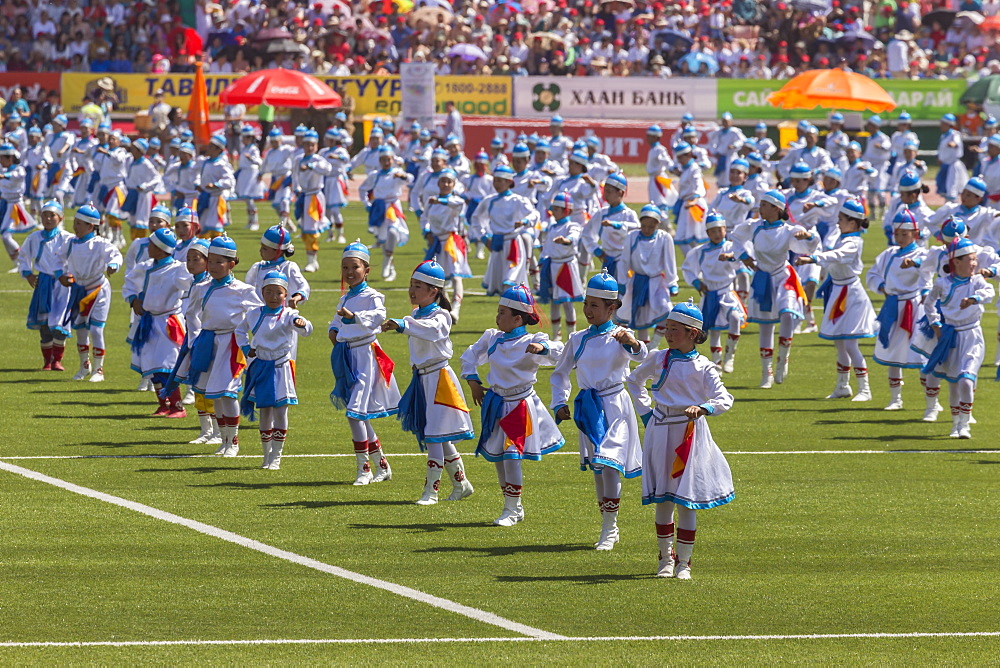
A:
122 228 193 418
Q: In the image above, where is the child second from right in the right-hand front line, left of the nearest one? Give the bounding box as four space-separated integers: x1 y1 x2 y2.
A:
867 210 928 417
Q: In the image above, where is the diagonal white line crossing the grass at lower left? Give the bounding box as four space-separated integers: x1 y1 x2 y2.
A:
0 462 563 640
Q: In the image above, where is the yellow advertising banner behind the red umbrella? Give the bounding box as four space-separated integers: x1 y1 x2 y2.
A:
62 72 513 116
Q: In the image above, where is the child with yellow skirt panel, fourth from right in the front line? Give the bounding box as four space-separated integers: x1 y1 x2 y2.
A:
382 258 475 506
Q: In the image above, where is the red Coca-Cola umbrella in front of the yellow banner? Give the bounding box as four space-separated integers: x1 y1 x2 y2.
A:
219 68 342 109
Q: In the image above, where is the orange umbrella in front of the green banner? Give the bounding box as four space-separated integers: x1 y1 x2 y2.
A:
767 69 896 113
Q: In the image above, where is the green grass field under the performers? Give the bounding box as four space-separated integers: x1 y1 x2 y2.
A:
0 205 1000 665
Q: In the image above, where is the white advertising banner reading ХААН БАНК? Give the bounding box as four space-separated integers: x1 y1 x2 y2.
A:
514 77 718 121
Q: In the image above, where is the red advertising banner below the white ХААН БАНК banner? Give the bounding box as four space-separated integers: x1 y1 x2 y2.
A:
462 116 716 163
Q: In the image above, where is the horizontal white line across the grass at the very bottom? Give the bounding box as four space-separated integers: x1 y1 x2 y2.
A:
0 631 1000 647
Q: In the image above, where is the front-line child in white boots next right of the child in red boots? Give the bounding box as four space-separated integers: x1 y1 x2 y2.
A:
174 236 263 457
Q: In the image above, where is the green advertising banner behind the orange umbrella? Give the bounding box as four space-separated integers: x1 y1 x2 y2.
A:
716 79 967 121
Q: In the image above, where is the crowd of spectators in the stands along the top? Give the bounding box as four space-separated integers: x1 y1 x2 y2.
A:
0 0 1000 79
